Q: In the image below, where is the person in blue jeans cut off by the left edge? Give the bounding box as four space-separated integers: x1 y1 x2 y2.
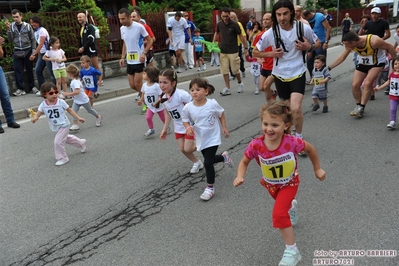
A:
0 36 20 134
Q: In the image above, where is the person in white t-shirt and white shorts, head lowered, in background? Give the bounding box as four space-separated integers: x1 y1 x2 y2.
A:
167 11 192 73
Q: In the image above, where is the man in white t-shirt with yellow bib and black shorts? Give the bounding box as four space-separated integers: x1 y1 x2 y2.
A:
118 8 152 105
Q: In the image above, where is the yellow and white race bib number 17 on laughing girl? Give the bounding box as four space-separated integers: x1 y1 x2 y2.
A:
259 152 296 185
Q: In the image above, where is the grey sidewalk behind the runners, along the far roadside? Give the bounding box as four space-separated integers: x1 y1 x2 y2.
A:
0 24 396 121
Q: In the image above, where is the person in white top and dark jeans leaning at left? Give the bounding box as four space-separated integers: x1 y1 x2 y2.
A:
29 16 57 96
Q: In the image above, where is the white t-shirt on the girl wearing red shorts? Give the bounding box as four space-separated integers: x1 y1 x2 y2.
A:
163 89 191 134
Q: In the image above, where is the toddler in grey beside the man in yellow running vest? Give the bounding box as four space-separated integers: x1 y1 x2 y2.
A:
309 54 331 113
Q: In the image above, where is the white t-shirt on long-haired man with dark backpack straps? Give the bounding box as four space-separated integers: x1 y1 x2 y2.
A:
256 21 318 79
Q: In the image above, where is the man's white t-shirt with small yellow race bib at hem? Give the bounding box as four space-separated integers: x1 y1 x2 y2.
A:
120 21 148 65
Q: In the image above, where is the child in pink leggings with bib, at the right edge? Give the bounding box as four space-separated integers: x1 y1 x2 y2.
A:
374 56 399 129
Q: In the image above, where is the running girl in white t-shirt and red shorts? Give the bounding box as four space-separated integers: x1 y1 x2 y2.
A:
156 69 204 174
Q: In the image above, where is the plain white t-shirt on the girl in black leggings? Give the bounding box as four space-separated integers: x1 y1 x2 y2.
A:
183 99 224 151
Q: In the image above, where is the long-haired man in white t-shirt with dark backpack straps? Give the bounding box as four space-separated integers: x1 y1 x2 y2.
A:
253 0 321 152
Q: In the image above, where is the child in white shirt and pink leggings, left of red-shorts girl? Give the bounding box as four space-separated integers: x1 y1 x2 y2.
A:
137 66 165 137
